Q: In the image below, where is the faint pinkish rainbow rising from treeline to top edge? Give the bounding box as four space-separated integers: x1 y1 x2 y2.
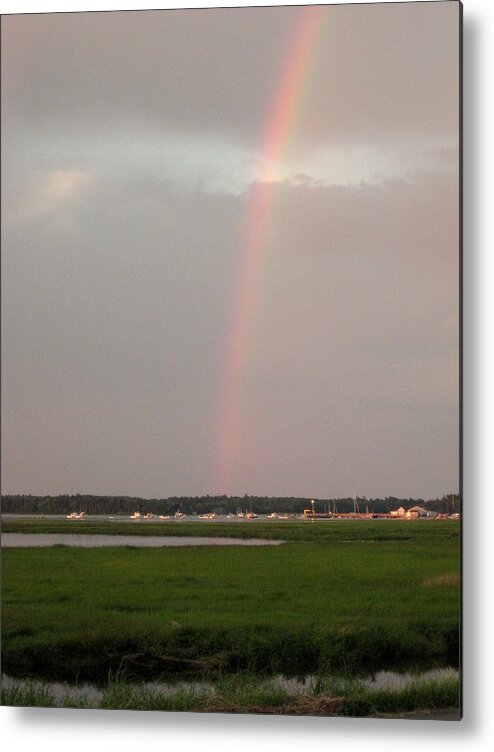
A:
213 5 325 494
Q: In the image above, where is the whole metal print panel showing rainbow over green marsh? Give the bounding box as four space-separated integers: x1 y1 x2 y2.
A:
2 0 462 720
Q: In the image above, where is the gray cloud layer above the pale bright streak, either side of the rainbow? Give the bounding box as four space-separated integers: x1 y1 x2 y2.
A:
3 2 459 148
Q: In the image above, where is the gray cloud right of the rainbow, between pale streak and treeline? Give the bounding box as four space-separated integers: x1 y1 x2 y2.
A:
237 167 459 495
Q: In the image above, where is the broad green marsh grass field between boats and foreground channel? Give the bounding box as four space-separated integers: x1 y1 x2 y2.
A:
2 520 459 682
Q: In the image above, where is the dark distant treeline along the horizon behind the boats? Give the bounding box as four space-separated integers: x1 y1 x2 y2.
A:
1 494 461 515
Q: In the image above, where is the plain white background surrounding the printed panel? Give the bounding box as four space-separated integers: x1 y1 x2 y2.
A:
0 0 494 752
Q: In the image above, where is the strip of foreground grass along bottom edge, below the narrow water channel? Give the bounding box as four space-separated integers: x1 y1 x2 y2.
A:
2 674 459 717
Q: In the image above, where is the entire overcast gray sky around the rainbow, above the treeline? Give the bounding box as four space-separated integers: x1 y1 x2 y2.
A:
2 0 459 498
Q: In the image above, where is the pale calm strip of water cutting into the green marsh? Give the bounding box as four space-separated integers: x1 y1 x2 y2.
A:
2 533 283 548
